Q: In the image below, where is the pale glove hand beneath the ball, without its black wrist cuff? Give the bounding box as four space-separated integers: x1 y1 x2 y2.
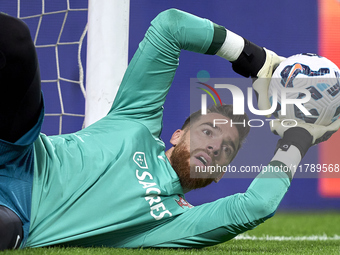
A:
270 119 340 145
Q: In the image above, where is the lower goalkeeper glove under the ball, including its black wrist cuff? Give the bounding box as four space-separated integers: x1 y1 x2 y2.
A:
270 119 340 158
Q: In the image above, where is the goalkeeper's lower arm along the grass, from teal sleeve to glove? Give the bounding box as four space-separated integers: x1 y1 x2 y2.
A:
137 120 340 248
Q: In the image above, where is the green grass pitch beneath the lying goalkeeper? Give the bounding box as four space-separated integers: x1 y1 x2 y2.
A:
0 212 340 255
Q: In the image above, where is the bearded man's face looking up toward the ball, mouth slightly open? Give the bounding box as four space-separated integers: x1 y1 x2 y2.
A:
171 113 239 189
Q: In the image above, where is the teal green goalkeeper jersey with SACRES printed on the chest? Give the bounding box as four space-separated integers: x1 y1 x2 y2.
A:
25 10 290 247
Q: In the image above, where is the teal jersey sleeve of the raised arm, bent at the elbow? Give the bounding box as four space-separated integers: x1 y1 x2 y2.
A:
109 9 223 137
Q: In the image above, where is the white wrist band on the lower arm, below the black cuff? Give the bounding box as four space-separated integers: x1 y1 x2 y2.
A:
271 145 301 177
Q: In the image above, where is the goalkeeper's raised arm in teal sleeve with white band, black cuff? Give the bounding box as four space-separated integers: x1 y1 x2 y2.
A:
109 9 276 137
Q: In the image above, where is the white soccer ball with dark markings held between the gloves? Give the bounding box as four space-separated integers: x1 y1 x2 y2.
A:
268 54 340 126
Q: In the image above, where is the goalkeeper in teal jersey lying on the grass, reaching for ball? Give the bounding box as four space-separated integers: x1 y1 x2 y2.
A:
0 9 339 249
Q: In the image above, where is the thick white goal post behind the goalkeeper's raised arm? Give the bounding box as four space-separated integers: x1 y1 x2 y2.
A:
85 0 130 127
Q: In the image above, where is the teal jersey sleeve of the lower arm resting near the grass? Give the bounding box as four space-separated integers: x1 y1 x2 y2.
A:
138 166 290 248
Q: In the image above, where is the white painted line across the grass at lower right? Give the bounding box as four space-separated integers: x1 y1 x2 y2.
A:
234 234 340 241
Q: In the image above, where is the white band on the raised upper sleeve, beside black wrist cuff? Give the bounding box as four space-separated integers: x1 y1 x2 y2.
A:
216 29 244 61
